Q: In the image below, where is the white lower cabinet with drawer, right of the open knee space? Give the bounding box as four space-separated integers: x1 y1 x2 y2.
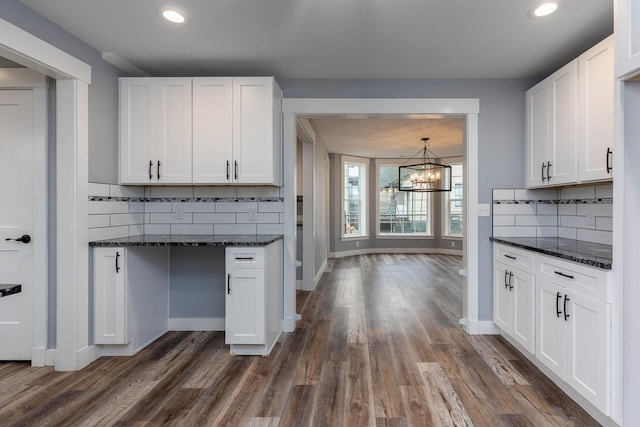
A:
225 241 283 355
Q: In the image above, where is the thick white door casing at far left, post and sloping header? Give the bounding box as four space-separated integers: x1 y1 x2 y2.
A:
0 19 95 371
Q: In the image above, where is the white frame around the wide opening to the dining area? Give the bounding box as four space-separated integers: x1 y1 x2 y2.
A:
282 98 483 334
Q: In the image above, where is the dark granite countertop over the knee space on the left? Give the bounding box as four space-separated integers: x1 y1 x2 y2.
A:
89 234 284 247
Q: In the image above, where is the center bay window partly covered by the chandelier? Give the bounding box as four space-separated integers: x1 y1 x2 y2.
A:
376 160 432 236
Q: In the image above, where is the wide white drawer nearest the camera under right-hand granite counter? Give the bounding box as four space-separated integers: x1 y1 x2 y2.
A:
536 255 611 302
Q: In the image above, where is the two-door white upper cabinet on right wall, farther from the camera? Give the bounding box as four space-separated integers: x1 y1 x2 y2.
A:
525 60 578 187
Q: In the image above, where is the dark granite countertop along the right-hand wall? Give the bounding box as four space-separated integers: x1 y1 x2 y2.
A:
491 237 612 270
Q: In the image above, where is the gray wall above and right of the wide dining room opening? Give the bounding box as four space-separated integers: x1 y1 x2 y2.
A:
279 79 538 320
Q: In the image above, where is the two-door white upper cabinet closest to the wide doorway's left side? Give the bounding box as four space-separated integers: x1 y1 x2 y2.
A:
193 77 282 185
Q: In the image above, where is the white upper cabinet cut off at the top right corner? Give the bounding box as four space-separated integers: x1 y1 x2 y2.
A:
614 0 640 78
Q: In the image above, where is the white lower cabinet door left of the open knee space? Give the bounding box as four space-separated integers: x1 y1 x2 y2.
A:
93 248 128 344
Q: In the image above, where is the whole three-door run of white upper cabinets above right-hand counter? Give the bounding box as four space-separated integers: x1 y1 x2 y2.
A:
525 37 614 188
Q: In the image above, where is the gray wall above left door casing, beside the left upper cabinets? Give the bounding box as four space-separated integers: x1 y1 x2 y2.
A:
0 0 126 184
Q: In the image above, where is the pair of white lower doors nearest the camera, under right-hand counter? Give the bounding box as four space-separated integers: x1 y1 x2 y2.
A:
536 279 611 414
